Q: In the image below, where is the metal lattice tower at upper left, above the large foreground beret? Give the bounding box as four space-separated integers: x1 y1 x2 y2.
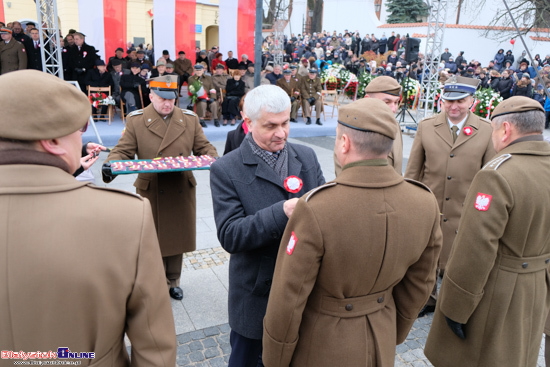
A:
36 0 63 79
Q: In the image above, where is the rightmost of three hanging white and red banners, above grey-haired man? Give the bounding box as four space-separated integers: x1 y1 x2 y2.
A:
220 0 256 61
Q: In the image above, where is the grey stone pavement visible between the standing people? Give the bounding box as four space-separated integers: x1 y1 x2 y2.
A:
87 125 548 367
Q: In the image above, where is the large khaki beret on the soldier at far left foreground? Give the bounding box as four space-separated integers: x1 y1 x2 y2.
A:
0 70 92 140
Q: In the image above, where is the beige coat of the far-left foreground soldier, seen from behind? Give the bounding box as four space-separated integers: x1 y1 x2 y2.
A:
0 165 176 367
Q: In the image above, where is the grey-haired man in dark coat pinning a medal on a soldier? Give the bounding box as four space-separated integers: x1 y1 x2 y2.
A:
210 85 325 367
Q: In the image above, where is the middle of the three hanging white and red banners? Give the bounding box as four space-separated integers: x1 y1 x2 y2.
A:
153 0 196 64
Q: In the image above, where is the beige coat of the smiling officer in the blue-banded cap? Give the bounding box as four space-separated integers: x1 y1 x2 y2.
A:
405 112 495 270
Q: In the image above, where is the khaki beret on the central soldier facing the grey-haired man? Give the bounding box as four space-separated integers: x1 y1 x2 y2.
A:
338 98 397 139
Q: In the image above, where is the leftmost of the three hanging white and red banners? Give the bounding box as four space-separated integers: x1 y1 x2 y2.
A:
78 0 127 62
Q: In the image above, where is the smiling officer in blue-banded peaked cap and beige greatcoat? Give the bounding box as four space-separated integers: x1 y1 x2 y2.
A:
405 77 495 316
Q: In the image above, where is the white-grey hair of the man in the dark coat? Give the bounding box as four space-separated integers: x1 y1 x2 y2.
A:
244 85 290 123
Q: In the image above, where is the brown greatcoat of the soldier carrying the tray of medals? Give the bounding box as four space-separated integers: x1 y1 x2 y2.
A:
104 104 218 256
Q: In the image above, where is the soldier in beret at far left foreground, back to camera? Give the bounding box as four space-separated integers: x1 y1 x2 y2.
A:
0 70 176 367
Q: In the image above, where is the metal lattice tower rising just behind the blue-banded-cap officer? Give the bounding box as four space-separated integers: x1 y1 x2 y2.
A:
416 0 447 121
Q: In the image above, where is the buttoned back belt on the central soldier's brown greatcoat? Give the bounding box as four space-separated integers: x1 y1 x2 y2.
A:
320 289 392 318
